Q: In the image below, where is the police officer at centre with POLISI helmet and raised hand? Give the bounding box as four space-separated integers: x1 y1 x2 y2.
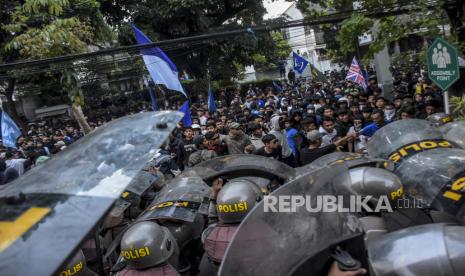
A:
200 178 261 276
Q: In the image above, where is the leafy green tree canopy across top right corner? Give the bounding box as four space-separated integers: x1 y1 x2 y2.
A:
298 0 465 62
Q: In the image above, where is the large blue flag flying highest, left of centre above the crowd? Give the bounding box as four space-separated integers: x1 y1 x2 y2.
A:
132 25 187 98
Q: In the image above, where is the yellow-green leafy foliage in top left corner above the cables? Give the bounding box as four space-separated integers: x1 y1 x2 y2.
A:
2 0 111 59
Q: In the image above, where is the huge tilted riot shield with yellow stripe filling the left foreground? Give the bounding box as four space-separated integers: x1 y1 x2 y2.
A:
0 112 183 275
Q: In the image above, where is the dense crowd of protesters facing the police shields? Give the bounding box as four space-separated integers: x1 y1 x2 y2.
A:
0 67 443 184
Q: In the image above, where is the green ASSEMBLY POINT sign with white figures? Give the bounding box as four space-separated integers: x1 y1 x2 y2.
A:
426 38 460 90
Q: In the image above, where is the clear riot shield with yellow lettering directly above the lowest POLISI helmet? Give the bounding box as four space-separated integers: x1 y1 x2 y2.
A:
137 177 211 222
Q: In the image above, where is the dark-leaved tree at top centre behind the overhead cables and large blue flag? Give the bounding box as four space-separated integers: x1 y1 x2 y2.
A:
111 0 288 80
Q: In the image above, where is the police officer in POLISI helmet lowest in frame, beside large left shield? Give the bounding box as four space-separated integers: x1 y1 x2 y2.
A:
113 221 181 276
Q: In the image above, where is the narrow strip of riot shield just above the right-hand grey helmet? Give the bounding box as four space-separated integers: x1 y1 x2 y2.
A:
311 151 394 171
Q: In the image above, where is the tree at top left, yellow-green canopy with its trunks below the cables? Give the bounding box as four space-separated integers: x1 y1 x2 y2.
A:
0 0 112 132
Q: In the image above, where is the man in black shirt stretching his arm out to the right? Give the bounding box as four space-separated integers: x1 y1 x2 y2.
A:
300 130 354 166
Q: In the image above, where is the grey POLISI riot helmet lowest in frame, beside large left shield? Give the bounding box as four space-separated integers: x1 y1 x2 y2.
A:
121 221 177 269
